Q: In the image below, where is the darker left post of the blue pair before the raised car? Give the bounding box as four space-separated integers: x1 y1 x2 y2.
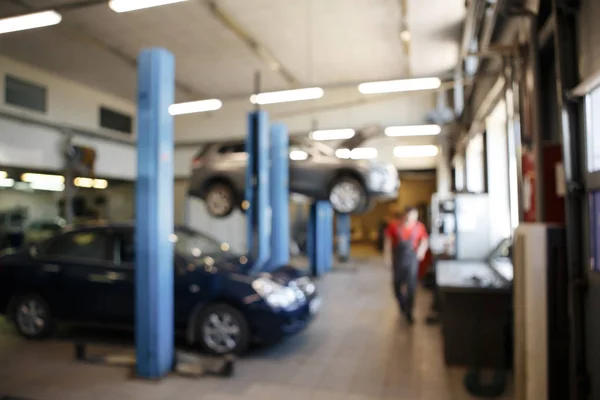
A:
246 111 271 270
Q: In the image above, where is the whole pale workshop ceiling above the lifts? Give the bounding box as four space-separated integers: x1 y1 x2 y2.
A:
0 0 465 101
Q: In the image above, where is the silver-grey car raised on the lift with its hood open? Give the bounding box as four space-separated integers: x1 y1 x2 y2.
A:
188 140 400 217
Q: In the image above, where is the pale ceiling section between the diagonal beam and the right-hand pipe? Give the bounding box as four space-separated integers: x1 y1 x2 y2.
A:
219 0 405 85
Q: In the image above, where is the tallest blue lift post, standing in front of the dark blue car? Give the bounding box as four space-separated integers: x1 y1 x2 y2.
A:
135 48 175 378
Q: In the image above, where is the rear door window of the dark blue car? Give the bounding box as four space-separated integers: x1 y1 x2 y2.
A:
44 231 112 261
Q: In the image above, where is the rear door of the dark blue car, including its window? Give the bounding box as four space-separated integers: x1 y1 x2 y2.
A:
38 229 114 322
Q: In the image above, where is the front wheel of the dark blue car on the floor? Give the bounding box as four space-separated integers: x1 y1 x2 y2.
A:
196 303 250 355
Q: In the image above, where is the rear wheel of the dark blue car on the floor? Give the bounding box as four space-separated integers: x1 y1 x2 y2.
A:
11 294 54 340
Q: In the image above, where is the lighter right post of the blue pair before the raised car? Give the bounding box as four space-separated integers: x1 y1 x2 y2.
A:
264 124 290 271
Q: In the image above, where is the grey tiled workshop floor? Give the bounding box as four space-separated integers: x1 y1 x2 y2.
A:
0 263 511 400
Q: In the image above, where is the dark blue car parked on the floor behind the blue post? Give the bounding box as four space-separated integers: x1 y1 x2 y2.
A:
0 225 320 354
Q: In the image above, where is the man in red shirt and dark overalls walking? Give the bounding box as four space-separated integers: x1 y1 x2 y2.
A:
385 207 429 324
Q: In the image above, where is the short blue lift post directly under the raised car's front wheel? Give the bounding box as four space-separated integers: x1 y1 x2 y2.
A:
307 200 333 276
